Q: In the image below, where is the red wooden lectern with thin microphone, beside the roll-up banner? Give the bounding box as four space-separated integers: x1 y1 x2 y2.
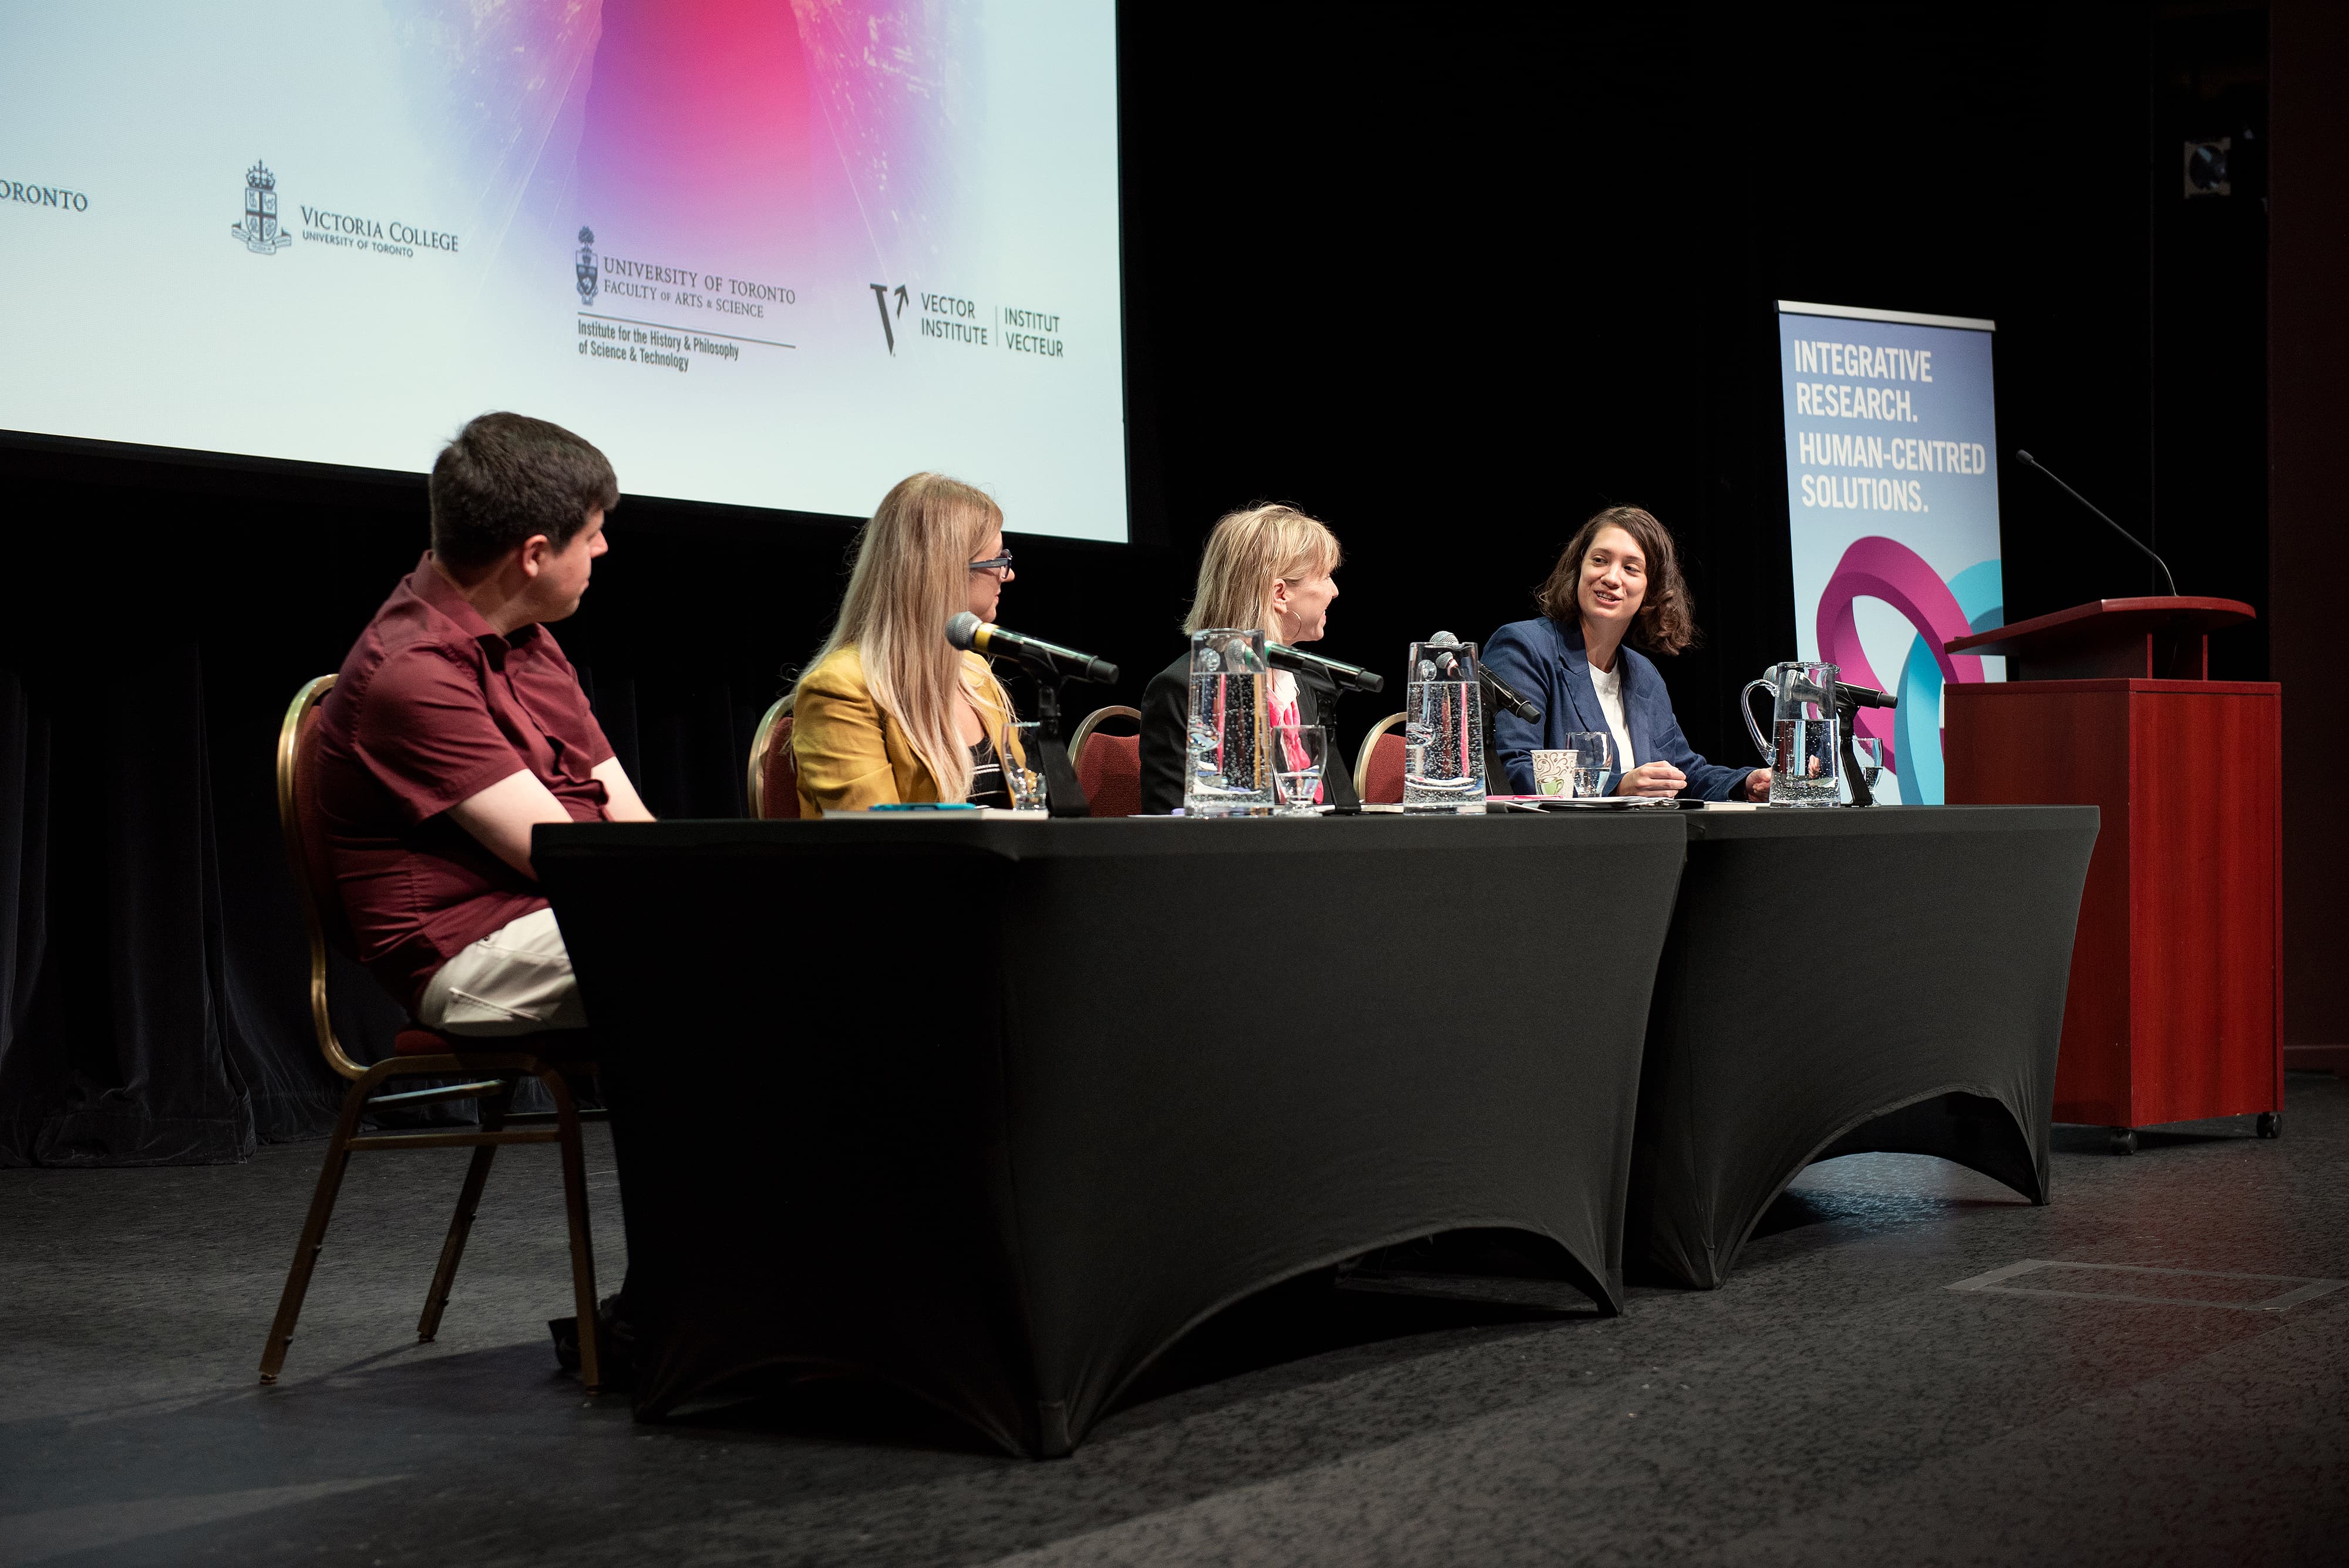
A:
1943 598 2283 1153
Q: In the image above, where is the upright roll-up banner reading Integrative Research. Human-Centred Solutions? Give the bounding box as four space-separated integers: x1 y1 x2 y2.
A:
1778 301 2006 805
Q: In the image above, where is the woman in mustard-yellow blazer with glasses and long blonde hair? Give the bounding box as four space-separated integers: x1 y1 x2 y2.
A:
792 474 1024 817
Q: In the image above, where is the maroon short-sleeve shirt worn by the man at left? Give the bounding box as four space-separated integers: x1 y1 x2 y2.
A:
312 554 613 1007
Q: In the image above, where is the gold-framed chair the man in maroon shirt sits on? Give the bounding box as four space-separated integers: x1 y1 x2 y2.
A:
261 676 604 1394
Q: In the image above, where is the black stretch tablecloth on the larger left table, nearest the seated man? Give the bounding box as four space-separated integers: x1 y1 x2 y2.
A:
533 812 1691 1453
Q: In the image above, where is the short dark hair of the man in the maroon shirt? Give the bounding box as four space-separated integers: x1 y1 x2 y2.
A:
430 413 620 566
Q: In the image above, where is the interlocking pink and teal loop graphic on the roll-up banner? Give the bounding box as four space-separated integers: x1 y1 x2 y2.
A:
1818 535 2006 805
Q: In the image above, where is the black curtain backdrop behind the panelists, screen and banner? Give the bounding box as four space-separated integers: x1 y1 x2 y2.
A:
0 2 2274 1165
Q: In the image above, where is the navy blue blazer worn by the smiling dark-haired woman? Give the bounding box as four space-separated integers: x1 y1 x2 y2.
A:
1485 617 1752 800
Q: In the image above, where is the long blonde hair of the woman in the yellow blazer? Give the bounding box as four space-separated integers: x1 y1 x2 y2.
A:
794 474 1012 800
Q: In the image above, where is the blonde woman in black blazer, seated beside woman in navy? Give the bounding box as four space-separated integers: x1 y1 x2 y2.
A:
1142 507 1358 817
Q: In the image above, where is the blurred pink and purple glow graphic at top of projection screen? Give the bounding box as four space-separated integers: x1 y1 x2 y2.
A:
395 0 963 287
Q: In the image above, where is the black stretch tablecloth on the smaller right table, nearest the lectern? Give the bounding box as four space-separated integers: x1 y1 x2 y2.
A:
1628 805 2098 1286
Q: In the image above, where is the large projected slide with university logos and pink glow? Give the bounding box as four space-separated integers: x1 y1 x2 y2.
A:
0 0 1128 540
